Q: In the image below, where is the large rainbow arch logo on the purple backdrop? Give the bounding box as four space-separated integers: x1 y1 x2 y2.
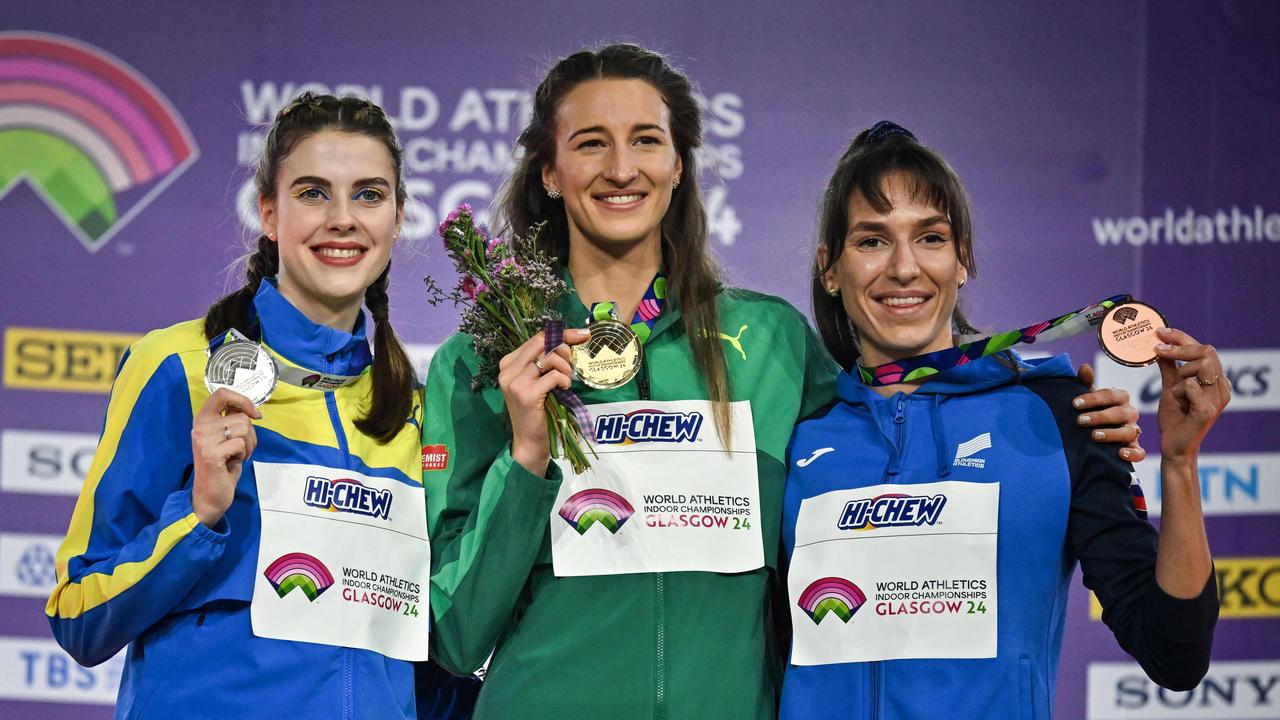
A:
0 32 200 252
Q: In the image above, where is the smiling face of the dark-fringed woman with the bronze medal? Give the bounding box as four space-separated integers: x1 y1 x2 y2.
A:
818 173 966 365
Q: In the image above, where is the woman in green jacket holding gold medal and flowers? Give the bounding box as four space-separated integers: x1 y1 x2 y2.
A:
424 45 1126 719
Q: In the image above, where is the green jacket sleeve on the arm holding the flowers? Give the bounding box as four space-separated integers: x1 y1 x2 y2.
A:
422 334 561 675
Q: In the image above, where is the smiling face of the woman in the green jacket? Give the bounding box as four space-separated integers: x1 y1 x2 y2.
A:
543 79 682 255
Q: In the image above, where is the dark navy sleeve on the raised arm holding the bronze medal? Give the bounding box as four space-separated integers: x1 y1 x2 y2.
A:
1033 379 1219 691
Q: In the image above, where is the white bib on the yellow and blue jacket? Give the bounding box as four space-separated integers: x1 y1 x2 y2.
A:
250 462 431 660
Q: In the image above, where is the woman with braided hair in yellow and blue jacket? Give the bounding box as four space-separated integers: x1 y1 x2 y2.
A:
47 94 430 717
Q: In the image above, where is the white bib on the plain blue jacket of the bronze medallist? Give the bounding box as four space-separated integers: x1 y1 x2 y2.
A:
787 482 1000 665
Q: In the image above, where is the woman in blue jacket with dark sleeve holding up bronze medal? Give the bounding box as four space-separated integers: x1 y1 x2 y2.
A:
782 123 1230 720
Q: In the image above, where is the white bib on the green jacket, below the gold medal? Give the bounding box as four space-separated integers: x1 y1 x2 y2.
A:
550 400 764 577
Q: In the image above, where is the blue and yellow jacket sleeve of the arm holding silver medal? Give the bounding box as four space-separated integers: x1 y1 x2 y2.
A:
45 338 227 665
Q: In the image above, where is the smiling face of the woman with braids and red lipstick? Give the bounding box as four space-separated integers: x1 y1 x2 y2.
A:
259 129 403 332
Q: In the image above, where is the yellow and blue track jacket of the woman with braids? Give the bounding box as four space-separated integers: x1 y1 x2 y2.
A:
46 282 426 719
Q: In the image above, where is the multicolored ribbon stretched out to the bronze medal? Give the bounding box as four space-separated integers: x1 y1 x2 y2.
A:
858 295 1133 387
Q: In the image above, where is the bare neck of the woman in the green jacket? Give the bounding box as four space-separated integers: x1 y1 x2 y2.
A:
568 232 662 323
